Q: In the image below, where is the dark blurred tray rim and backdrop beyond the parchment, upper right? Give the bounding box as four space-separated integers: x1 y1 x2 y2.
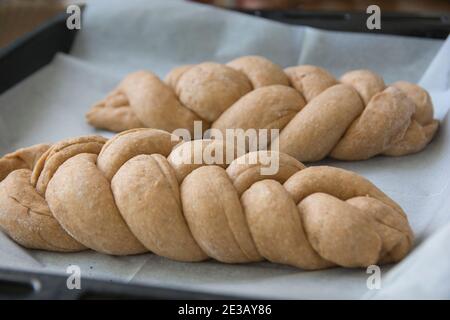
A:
195 0 450 39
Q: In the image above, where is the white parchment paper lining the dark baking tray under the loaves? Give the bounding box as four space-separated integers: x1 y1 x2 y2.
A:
0 0 450 299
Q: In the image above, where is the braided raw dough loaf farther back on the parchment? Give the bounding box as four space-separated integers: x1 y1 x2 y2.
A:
87 56 438 161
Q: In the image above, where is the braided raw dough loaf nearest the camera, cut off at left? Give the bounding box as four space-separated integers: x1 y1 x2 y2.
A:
0 129 413 269
